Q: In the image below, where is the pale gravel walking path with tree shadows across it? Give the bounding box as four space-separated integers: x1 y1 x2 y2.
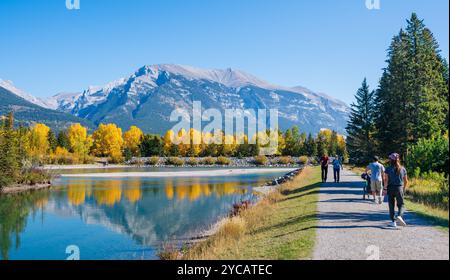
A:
313 168 449 260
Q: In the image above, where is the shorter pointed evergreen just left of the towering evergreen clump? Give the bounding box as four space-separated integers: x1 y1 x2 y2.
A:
348 79 376 163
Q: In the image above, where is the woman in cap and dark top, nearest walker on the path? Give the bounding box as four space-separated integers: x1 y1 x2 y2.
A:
384 153 408 228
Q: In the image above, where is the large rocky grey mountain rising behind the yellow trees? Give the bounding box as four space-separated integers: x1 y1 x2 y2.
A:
45 64 349 133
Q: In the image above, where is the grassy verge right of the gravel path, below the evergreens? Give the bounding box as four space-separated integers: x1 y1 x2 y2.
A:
348 166 449 231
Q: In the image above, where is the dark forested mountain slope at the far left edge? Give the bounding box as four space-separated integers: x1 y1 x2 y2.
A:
0 86 94 131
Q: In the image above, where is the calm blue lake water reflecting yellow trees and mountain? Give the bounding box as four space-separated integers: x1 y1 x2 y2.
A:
0 169 282 260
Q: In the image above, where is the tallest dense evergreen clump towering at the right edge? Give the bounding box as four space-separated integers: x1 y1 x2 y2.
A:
376 14 449 156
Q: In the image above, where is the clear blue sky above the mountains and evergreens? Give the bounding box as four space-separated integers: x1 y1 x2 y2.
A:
0 0 449 103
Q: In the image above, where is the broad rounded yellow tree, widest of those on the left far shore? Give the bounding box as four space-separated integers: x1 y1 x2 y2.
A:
92 124 123 162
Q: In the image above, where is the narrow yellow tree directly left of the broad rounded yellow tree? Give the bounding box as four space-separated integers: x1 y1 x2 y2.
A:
67 123 93 163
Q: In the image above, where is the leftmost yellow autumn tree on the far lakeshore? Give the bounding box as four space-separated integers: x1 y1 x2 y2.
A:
28 123 50 163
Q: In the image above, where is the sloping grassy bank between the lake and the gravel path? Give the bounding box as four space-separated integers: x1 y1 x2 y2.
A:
171 167 320 259
